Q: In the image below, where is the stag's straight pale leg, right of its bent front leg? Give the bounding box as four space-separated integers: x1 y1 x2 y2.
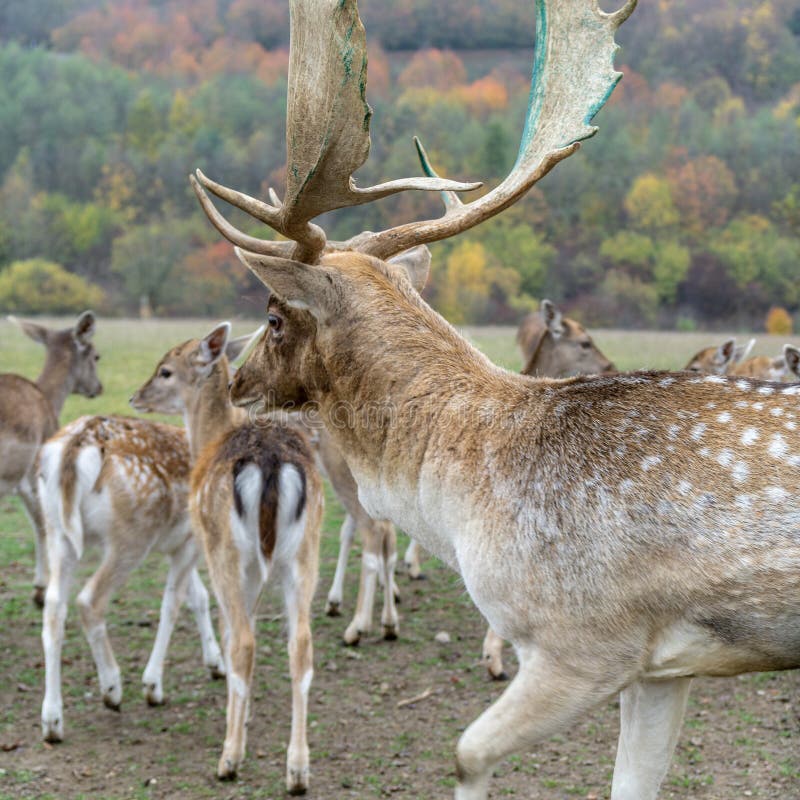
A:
611 678 692 800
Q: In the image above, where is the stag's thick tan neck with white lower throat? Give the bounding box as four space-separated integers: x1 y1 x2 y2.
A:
315 294 543 563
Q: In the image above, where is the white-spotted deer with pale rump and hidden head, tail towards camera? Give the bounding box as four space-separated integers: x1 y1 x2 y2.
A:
38 416 224 742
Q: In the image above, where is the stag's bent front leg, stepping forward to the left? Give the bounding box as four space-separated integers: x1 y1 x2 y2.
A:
455 651 618 800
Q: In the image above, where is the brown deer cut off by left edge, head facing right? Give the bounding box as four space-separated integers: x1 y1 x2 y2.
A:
0 311 103 606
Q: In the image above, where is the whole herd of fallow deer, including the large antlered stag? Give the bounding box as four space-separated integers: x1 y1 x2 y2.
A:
0 0 800 800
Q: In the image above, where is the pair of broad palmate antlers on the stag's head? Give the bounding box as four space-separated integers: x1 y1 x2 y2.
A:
191 0 636 264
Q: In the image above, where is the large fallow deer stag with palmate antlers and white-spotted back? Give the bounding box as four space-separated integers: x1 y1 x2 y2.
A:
194 0 800 800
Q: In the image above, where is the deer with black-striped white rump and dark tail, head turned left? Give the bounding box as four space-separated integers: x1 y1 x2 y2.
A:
131 323 323 794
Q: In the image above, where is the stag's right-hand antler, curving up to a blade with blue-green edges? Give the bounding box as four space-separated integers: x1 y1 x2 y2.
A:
348 0 636 259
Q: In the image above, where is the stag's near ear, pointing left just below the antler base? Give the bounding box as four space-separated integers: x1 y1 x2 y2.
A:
234 252 337 320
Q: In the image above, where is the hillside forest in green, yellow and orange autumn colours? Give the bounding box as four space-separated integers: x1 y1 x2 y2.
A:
0 0 800 329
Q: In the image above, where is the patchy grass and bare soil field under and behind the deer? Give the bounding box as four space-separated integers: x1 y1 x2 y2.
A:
0 320 800 800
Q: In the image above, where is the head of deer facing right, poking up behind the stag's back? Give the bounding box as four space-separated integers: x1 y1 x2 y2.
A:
517 300 616 378
